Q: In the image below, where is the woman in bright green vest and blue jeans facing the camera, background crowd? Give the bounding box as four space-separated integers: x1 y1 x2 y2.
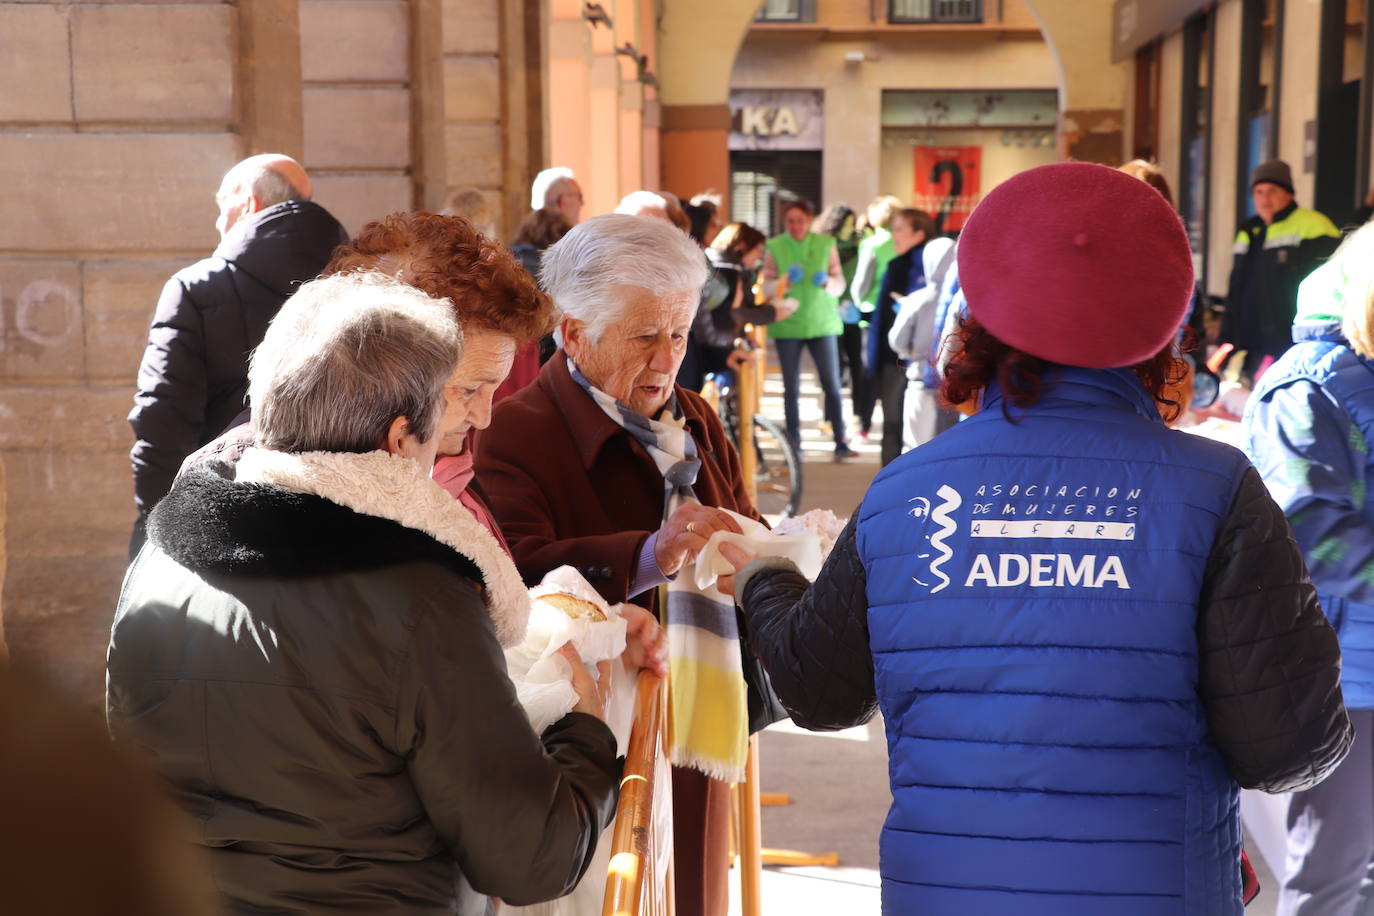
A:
764 199 856 461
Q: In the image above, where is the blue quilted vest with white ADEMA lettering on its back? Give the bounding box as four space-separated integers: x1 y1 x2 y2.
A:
857 368 1248 916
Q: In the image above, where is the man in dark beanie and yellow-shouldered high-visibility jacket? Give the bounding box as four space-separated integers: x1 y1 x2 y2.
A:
1221 159 1341 385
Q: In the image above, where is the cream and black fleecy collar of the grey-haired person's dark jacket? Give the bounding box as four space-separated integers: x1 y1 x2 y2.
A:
148 448 529 647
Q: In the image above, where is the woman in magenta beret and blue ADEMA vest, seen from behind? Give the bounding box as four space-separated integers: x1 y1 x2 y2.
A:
725 162 1352 916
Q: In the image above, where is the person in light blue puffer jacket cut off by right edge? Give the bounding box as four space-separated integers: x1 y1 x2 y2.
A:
1243 225 1374 916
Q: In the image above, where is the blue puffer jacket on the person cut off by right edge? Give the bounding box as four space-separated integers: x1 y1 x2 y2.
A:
1245 323 1374 709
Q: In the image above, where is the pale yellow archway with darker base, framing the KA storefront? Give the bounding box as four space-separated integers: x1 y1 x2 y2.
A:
658 0 1127 194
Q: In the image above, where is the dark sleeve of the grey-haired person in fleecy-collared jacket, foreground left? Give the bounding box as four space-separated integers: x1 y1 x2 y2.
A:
396 596 621 905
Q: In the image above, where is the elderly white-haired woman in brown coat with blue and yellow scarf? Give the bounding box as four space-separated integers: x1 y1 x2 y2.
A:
477 214 767 916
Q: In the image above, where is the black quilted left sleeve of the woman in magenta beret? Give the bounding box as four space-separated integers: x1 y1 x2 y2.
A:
735 511 878 732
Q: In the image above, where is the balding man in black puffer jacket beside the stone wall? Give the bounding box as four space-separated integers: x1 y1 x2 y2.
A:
129 154 348 559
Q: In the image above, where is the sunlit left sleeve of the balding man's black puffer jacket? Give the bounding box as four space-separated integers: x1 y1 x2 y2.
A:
129 271 209 514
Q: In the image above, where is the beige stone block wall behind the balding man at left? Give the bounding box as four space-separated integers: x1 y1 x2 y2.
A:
0 0 543 705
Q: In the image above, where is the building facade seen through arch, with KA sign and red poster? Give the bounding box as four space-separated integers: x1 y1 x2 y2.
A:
730 0 1059 231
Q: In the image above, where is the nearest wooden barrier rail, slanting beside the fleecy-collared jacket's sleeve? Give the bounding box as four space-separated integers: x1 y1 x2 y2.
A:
602 672 671 916
